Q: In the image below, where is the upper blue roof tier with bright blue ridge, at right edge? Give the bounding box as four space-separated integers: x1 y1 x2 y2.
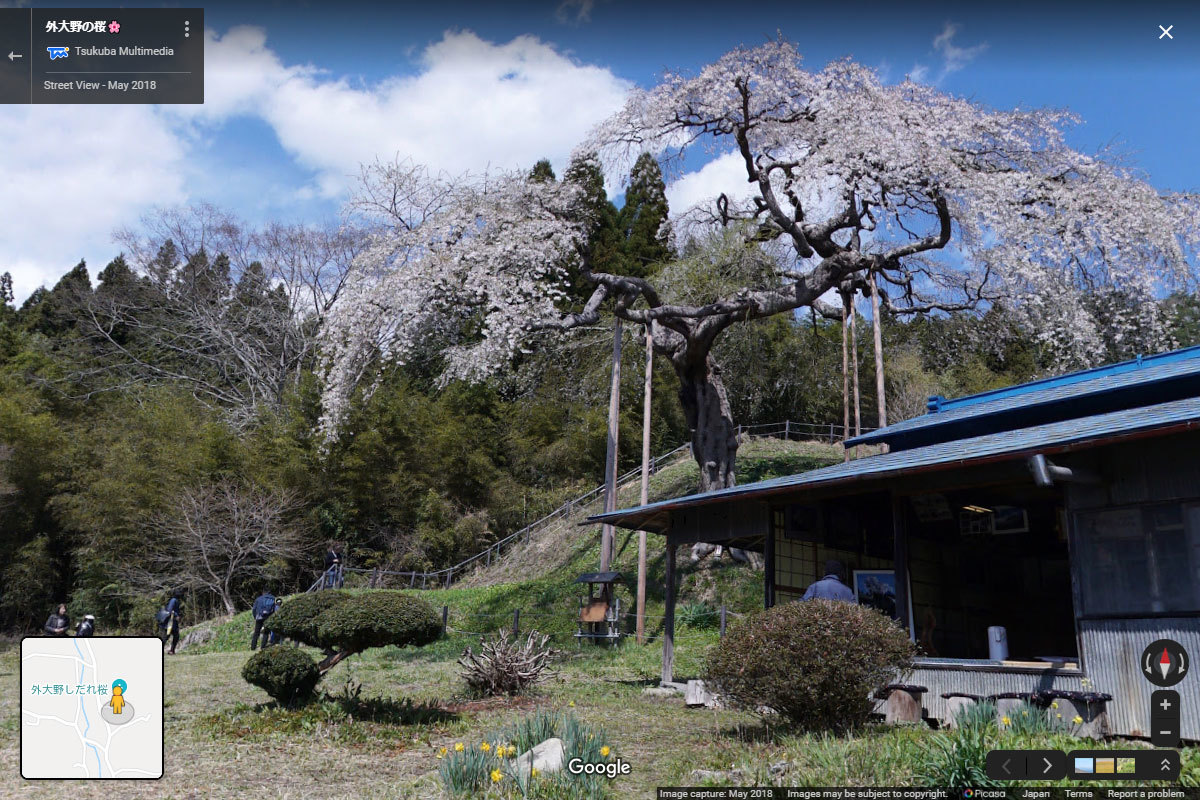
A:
846 347 1200 449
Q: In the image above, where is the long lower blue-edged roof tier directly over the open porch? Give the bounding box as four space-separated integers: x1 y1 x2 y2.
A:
588 397 1200 530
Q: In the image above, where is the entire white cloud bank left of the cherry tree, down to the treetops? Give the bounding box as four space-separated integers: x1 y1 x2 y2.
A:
0 26 629 299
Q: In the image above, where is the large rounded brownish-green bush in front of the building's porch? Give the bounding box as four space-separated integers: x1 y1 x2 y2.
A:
707 600 914 730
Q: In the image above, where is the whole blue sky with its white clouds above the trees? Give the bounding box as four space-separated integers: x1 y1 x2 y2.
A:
0 0 1200 297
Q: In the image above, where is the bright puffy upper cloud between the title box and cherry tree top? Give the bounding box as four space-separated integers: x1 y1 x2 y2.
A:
181 28 630 196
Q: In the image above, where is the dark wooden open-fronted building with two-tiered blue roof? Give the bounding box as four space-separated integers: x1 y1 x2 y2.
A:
594 348 1200 740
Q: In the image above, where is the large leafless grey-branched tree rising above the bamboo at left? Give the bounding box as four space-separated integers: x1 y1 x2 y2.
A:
72 204 362 426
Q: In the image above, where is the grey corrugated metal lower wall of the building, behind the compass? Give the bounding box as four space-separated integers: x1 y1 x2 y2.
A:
1079 618 1200 741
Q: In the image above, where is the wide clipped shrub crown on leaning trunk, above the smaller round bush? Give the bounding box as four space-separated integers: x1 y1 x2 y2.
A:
312 591 442 652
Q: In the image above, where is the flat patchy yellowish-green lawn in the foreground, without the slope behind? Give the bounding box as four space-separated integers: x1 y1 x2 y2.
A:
0 628 1200 800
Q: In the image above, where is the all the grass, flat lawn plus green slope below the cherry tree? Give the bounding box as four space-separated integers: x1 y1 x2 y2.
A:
0 440 1200 800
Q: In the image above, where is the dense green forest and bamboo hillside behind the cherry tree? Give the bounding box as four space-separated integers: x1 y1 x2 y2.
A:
0 160 1200 631
